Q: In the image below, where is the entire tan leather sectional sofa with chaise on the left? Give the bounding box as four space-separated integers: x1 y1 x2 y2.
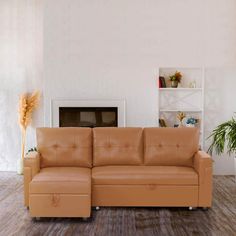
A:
24 128 212 217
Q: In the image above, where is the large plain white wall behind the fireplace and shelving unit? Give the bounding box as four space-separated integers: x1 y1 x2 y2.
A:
0 0 236 174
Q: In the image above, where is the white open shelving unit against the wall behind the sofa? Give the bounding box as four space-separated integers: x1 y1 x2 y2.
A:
158 67 205 149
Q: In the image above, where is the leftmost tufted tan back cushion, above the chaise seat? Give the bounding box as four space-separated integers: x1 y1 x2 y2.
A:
36 128 92 167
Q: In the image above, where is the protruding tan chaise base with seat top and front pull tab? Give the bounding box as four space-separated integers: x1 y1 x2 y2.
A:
29 167 91 217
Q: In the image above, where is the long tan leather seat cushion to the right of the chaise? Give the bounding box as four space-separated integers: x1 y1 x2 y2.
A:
92 166 198 185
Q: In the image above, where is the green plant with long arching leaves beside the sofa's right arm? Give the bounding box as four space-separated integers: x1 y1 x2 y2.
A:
208 117 236 177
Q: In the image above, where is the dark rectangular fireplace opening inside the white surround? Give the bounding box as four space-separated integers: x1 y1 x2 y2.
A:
59 107 118 128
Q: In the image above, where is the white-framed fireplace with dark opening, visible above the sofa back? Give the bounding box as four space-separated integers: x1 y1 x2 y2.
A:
49 99 126 127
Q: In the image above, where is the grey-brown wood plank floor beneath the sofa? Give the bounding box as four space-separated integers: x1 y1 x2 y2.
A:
0 172 236 236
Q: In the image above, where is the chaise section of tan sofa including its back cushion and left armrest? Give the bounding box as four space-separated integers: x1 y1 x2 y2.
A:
24 128 92 217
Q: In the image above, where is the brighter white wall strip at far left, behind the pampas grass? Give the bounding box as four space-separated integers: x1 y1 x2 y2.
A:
0 0 43 171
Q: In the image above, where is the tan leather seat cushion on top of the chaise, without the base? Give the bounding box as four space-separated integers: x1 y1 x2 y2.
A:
29 167 91 194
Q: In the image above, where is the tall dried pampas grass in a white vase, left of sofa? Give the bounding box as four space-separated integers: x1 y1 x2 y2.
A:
17 90 40 174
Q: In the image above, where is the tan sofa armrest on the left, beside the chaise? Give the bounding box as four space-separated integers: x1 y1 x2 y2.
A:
24 152 40 206
